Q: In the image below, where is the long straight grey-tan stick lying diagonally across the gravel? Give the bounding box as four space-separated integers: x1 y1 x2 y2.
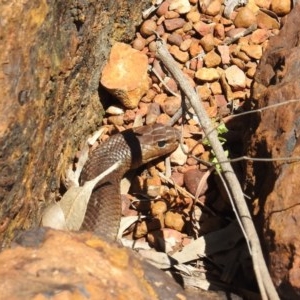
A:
157 40 279 300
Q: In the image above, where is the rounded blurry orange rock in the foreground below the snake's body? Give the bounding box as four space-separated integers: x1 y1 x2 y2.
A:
0 228 220 300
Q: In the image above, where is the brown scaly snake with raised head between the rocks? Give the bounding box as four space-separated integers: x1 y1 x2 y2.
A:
80 124 180 240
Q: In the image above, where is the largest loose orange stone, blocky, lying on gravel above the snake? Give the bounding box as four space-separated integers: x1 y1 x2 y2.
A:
101 43 149 108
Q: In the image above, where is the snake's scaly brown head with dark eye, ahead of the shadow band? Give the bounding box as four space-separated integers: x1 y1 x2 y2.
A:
133 124 180 164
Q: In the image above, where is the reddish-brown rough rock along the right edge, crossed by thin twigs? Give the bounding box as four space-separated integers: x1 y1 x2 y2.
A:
245 5 300 299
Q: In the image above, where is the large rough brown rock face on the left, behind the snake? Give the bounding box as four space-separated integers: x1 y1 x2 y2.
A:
0 0 150 245
